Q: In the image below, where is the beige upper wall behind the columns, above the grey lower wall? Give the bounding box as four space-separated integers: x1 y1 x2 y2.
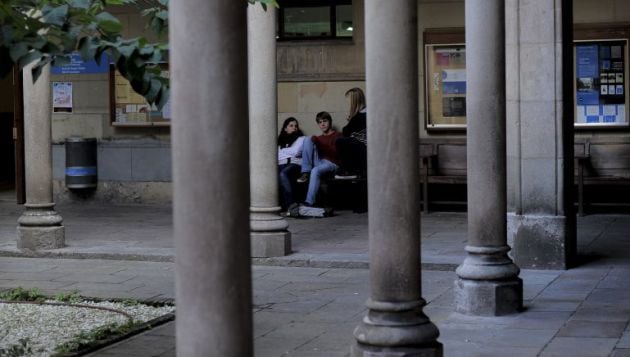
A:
51 0 630 142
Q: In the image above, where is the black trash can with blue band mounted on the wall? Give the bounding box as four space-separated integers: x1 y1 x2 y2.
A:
66 137 98 189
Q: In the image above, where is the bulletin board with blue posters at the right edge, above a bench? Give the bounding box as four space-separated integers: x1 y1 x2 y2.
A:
573 39 628 128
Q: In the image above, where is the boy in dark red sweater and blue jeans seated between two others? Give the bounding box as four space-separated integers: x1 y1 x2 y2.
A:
297 112 341 206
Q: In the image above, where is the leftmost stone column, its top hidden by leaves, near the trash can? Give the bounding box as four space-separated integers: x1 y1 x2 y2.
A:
17 64 65 250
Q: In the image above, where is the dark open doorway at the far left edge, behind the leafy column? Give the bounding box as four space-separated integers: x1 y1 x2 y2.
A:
0 70 25 204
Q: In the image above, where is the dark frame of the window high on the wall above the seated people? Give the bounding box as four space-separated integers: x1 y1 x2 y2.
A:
276 0 354 41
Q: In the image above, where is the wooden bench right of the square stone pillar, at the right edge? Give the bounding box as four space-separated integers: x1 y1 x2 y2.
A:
574 139 630 216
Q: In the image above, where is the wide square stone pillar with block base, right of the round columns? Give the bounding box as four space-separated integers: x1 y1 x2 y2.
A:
506 0 577 269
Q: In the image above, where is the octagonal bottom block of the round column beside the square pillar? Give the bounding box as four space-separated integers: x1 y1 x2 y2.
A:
454 278 523 316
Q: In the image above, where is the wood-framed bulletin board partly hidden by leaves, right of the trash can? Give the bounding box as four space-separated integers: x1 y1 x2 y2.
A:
109 64 171 127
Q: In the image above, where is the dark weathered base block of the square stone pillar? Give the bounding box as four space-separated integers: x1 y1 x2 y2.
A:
507 213 577 269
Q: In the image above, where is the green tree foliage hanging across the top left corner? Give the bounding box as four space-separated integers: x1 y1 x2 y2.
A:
0 0 278 107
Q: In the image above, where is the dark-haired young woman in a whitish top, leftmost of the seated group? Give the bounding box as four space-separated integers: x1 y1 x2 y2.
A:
278 117 304 211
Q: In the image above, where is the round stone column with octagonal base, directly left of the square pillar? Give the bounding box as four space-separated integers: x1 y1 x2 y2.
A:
455 0 523 315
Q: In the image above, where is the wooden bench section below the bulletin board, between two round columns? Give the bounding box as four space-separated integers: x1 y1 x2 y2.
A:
420 139 467 213
